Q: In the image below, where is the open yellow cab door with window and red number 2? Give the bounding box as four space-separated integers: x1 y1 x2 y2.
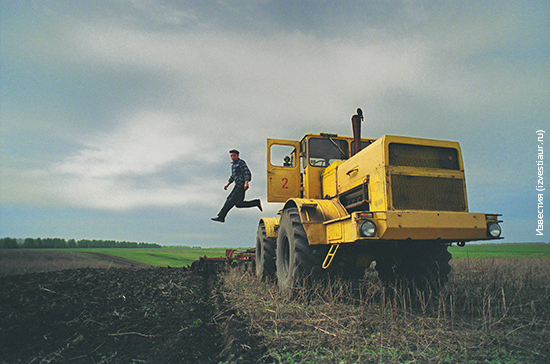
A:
267 139 301 202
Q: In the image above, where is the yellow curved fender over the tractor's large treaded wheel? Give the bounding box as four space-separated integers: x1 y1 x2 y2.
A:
283 198 349 245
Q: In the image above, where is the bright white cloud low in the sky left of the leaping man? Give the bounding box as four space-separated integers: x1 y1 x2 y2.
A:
4 111 221 210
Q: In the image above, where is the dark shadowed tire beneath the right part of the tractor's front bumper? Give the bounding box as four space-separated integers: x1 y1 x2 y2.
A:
376 242 451 289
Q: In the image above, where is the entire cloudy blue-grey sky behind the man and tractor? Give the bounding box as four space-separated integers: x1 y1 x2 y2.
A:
0 0 550 247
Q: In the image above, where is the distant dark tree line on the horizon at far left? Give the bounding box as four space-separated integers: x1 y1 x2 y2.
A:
0 237 162 249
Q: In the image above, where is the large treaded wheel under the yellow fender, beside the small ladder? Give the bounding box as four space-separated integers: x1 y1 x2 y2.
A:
276 207 327 290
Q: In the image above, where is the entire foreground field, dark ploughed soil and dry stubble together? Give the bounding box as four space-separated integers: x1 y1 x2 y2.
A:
0 249 550 364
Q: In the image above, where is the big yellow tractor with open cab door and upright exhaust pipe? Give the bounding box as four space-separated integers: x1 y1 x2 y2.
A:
256 109 502 288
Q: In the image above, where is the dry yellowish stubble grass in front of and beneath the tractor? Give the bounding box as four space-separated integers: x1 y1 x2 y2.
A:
218 258 550 363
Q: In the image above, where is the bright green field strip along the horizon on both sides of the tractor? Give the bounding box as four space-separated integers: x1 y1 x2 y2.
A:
64 243 550 267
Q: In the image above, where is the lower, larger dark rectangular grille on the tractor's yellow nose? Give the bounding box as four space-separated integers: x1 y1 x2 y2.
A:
391 174 466 211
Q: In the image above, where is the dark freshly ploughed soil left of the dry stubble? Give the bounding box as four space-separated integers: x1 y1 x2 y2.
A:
0 268 253 364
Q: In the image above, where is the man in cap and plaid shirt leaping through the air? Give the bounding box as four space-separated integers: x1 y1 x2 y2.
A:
212 149 263 222
